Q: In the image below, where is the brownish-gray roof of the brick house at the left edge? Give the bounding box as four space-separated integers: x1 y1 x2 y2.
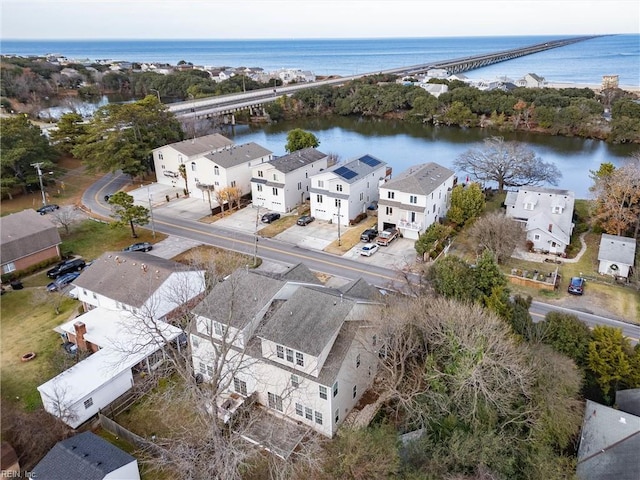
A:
0 209 61 265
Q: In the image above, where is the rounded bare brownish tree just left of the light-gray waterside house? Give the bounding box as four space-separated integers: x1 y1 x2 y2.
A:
468 212 526 263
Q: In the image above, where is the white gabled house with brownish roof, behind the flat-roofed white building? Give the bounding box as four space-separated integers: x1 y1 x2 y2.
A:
73 252 205 320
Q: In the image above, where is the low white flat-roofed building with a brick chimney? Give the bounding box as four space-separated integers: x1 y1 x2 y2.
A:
38 308 183 428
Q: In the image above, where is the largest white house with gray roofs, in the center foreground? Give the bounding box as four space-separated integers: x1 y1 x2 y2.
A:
190 265 381 437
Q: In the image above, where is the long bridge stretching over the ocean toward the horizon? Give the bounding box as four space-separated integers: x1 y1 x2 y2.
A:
168 35 599 121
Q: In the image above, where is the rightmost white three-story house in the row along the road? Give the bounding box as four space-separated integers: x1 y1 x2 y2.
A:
378 162 455 240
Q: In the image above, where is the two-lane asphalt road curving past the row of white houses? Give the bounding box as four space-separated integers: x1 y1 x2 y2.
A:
82 174 640 344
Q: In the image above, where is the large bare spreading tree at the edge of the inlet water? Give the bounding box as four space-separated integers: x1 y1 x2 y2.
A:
454 137 562 192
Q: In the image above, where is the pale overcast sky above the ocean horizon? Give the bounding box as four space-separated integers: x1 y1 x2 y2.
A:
0 0 640 40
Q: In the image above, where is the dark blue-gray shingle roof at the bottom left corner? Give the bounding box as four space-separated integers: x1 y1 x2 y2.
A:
32 432 136 480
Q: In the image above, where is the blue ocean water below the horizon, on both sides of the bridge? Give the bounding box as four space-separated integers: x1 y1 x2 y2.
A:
0 35 640 87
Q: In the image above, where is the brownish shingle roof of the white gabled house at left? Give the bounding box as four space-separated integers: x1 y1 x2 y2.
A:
73 252 185 307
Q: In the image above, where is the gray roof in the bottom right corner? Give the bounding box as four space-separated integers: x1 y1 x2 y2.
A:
576 400 640 480
